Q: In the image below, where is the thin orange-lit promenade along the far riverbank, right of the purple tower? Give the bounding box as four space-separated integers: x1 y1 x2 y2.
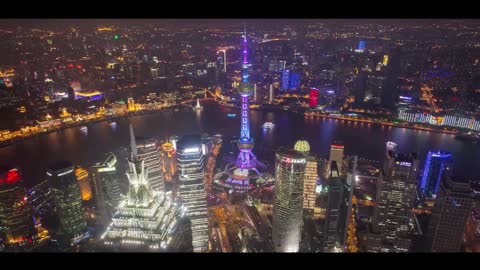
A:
304 112 458 135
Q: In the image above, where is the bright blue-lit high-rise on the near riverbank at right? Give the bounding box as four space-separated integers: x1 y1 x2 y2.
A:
420 151 452 197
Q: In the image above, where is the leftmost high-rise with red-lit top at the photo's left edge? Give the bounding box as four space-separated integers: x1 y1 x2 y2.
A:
0 168 33 245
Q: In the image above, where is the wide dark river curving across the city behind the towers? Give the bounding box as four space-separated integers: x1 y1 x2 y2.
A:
0 101 480 186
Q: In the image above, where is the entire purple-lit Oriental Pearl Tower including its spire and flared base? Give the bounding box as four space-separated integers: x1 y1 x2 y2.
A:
214 24 268 200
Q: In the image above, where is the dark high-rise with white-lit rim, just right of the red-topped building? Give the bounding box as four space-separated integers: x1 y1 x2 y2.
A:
47 161 87 242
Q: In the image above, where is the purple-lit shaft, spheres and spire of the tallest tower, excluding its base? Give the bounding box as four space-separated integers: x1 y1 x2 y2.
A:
235 27 258 170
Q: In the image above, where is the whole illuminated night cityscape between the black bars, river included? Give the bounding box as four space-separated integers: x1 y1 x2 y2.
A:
0 19 480 253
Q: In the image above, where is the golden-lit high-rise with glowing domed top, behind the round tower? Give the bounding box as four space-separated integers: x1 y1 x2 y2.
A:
293 140 318 214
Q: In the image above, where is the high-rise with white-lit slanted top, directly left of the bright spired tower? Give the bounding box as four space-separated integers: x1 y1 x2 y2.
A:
91 153 121 225
